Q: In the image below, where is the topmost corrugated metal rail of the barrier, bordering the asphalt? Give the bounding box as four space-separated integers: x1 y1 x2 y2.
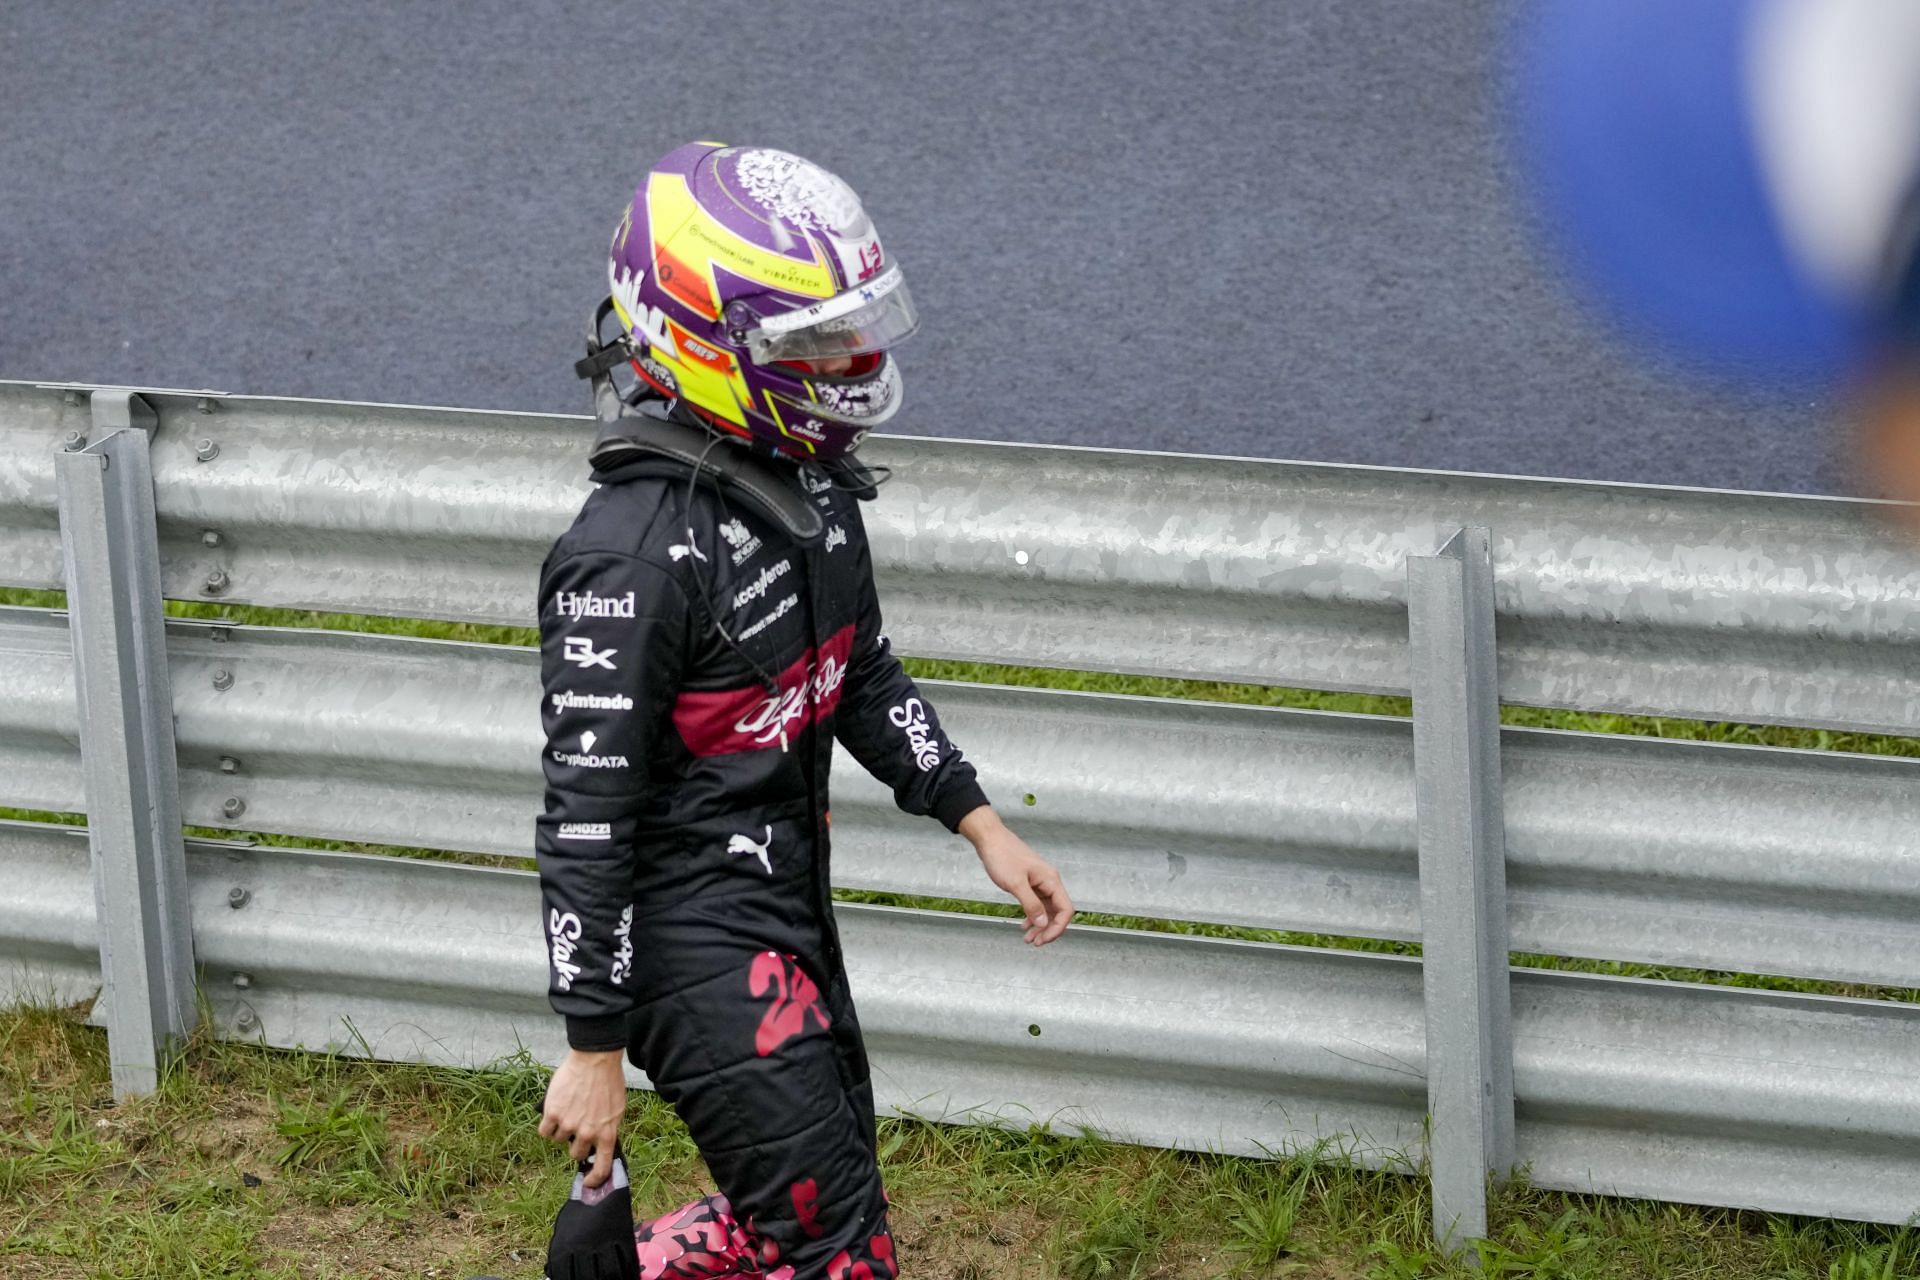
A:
0 382 1920 733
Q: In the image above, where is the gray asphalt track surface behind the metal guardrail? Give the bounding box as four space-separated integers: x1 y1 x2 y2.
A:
0 0 1851 491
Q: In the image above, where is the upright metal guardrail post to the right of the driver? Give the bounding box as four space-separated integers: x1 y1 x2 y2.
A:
1407 528 1513 1253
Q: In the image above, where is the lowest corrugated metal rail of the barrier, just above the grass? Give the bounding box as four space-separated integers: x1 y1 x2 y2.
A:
15 823 1920 1222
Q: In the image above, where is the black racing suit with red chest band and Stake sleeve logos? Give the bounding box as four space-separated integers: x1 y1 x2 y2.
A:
536 445 987 1280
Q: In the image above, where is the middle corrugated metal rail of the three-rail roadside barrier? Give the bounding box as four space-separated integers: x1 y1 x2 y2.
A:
11 608 1920 986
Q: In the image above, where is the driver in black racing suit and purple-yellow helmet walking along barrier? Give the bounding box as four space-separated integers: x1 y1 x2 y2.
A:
536 142 1073 1280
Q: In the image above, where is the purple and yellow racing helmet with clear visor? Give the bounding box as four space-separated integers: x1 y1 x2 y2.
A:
607 142 920 462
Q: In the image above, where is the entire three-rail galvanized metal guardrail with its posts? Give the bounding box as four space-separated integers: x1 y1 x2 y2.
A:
0 384 1920 1245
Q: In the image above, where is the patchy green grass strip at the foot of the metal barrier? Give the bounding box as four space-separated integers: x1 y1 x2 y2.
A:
0 1009 1920 1280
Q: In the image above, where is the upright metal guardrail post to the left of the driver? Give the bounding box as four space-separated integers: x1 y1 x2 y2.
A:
54 391 196 1100
